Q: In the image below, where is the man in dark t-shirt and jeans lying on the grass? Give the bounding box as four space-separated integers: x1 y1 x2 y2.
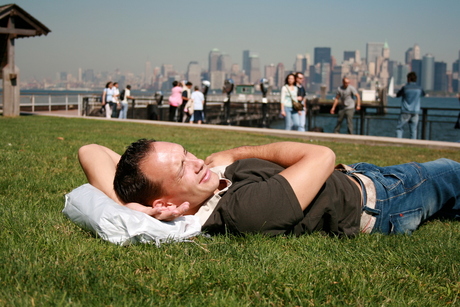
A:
78 139 460 236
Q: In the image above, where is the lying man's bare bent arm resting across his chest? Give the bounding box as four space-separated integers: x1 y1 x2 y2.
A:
205 142 335 210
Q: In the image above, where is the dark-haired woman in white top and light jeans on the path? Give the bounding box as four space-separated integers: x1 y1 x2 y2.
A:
281 74 300 131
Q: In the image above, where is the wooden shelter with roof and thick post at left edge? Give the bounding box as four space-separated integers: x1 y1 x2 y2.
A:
0 4 51 116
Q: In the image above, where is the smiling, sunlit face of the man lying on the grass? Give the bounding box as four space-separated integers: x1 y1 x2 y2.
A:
140 142 219 208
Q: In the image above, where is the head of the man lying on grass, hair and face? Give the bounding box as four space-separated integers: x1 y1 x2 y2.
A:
114 140 219 209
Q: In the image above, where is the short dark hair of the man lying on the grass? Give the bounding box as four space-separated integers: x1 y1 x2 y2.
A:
113 139 163 206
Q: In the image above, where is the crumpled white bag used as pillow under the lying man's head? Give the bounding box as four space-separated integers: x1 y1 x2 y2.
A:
62 183 201 246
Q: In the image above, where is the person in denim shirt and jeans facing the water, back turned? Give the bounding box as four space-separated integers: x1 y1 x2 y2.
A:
396 71 425 140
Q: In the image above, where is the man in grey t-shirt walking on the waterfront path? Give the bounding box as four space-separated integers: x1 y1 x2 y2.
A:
330 77 361 134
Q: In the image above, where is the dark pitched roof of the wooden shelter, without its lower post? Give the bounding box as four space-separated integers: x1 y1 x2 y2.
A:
0 4 51 78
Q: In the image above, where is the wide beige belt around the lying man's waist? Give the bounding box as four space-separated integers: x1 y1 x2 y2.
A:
336 164 377 233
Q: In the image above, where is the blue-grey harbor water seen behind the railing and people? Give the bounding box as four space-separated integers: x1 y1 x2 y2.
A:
12 90 460 142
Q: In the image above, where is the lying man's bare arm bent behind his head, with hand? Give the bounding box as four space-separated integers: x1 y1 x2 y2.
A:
78 144 189 221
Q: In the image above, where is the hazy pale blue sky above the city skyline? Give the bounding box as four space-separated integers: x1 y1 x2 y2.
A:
9 0 460 80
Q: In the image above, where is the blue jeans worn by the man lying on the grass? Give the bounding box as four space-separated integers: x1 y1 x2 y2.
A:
352 159 460 234
